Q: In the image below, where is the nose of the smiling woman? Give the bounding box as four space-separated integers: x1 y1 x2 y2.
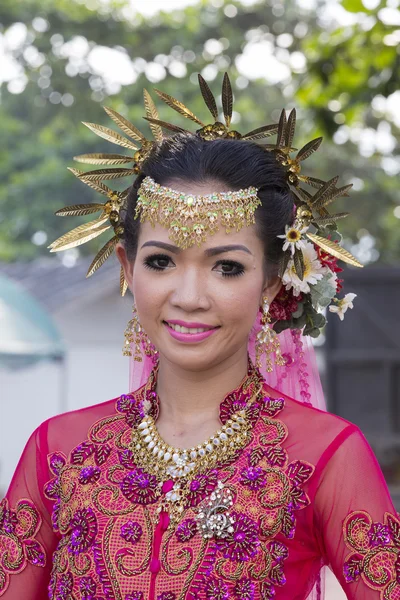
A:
170 267 211 313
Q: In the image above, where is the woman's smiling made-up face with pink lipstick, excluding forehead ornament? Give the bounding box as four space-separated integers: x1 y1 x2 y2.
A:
117 181 280 371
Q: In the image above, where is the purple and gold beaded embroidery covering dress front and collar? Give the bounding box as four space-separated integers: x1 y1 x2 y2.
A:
41 366 314 600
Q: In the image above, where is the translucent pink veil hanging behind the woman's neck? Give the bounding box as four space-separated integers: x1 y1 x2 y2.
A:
129 314 326 600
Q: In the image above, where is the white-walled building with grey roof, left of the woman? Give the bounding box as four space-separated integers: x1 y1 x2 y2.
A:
0 256 132 497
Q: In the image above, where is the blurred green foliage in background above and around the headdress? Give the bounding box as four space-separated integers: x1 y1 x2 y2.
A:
0 0 400 263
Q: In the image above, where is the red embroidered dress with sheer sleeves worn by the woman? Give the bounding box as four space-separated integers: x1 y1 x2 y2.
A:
0 366 400 600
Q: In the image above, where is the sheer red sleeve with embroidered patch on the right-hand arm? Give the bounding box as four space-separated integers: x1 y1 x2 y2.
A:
315 425 400 600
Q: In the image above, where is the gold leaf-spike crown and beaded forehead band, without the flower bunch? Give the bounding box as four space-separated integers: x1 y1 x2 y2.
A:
49 73 362 295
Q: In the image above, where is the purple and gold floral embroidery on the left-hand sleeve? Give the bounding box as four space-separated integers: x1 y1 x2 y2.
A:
0 498 46 596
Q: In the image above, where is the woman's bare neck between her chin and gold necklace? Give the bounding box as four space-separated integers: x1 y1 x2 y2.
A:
157 350 248 429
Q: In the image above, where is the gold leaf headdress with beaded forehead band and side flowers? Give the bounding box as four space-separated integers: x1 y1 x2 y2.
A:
49 73 362 337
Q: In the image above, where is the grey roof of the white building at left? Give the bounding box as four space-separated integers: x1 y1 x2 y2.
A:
0 254 120 312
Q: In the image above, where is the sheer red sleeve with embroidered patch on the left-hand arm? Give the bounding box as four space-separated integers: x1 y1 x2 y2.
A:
0 423 58 600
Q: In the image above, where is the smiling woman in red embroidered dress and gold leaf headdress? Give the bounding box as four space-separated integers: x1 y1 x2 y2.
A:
0 77 400 600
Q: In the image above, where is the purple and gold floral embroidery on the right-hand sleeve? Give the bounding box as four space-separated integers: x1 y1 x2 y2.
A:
343 511 400 600
